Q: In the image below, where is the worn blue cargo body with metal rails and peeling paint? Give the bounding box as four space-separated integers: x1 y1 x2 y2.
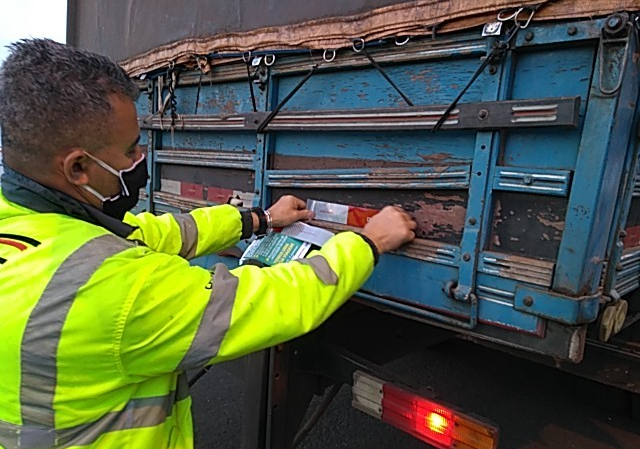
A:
138 15 640 362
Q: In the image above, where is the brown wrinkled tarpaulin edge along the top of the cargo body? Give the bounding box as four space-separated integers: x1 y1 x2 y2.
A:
70 0 640 76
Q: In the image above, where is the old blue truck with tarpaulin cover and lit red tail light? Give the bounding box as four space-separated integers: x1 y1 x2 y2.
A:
67 0 640 449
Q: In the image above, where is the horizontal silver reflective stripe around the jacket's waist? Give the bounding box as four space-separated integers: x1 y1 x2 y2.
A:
0 373 189 449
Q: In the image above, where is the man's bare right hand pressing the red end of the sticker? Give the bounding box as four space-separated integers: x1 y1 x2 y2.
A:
362 206 418 254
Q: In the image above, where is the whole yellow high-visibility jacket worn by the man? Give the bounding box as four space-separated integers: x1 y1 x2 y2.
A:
0 166 374 449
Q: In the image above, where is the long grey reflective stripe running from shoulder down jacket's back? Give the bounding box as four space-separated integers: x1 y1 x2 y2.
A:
20 234 133 440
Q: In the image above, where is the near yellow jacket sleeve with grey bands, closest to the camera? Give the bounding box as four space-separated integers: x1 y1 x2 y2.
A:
115 232 373 377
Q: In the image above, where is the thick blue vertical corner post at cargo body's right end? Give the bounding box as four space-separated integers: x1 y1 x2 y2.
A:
553 27 638 296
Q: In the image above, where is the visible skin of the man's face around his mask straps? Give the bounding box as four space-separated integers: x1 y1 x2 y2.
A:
83 95 142 208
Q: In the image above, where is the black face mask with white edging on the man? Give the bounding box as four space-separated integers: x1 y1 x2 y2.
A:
82 153 149 220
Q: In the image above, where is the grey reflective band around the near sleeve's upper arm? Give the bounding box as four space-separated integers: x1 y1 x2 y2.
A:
177 264 238 370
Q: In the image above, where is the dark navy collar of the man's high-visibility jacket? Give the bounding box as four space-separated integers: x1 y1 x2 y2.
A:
0 165 136 238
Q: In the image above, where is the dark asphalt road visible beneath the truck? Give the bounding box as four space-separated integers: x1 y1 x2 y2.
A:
193 341 640 449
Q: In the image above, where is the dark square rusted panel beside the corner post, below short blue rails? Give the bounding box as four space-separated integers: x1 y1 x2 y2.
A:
489 192 567 260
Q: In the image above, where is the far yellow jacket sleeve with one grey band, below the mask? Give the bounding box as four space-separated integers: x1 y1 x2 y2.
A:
124 205 253 259
